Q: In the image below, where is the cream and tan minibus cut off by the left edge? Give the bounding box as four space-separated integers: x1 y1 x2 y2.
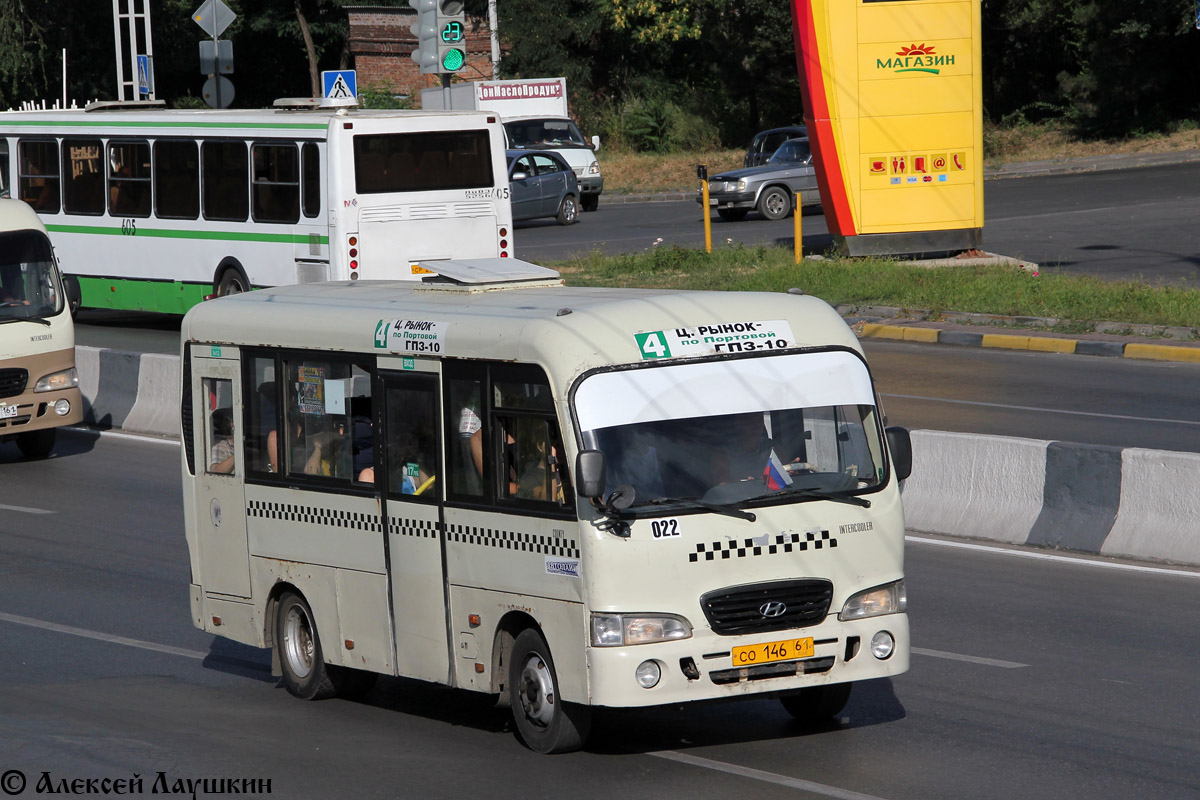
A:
0 199 83 458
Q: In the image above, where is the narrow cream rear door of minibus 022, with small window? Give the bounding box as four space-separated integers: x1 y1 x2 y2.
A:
192 347 250 597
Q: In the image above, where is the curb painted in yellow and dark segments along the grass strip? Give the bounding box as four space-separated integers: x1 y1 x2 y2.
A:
846 319 1200 363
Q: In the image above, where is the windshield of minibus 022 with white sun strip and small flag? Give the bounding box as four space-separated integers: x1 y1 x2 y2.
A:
575 350 884 507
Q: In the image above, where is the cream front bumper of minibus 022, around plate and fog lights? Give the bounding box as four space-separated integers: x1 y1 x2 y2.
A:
588 614 910 708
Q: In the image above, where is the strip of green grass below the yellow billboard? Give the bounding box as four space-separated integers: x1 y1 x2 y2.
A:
554 245 1200 330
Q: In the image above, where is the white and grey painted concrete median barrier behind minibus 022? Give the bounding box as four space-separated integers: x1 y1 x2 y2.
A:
76 347 1200 565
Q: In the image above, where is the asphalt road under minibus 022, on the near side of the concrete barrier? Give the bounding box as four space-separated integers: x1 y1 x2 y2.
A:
0 434 1200 800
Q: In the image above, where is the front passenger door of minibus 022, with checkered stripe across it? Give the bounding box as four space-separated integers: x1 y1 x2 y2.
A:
376 367 451 684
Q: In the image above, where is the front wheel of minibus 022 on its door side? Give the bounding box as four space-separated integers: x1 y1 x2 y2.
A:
509 628 592 753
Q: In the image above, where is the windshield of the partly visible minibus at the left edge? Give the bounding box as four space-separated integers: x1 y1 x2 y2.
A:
0 230 62 323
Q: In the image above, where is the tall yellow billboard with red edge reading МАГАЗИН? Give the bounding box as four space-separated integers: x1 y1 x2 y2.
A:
792 0 983 255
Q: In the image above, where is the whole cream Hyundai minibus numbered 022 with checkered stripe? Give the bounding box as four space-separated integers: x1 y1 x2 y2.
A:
181 259 911 752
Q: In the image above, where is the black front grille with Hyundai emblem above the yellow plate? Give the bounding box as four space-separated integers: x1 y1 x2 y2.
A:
700 578 833 636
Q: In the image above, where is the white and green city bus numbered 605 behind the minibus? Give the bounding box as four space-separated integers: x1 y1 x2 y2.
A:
0 106 514 313
